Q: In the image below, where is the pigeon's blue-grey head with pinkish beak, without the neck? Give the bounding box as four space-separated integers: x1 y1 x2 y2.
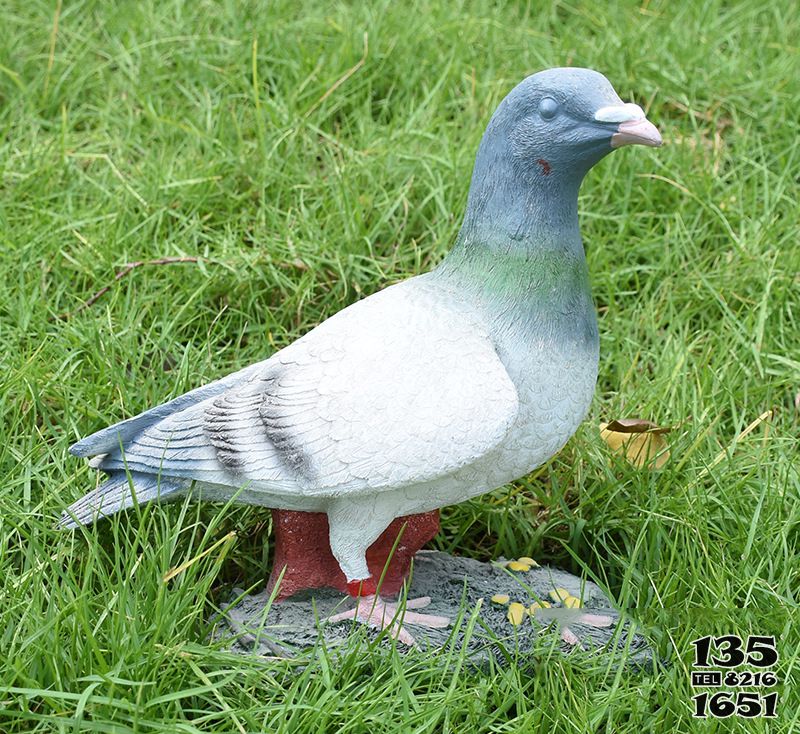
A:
481 68 661 184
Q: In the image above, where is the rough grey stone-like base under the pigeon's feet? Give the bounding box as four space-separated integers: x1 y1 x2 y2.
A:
214 551 652 666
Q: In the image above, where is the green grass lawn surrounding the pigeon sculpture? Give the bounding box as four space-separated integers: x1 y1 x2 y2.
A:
0 0 800 734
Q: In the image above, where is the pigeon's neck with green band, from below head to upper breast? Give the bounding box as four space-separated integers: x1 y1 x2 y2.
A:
433 161 597 351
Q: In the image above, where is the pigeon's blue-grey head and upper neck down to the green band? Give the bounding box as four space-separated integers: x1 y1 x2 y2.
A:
454 68 661 254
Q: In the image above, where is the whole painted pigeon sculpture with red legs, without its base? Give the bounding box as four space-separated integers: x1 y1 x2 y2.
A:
61 68 661 643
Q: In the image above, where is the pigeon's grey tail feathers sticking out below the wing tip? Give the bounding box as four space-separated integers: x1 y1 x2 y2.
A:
58 471 186 530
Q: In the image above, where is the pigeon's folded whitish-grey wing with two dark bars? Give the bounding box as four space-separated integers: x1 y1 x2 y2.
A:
87 281 518 496
